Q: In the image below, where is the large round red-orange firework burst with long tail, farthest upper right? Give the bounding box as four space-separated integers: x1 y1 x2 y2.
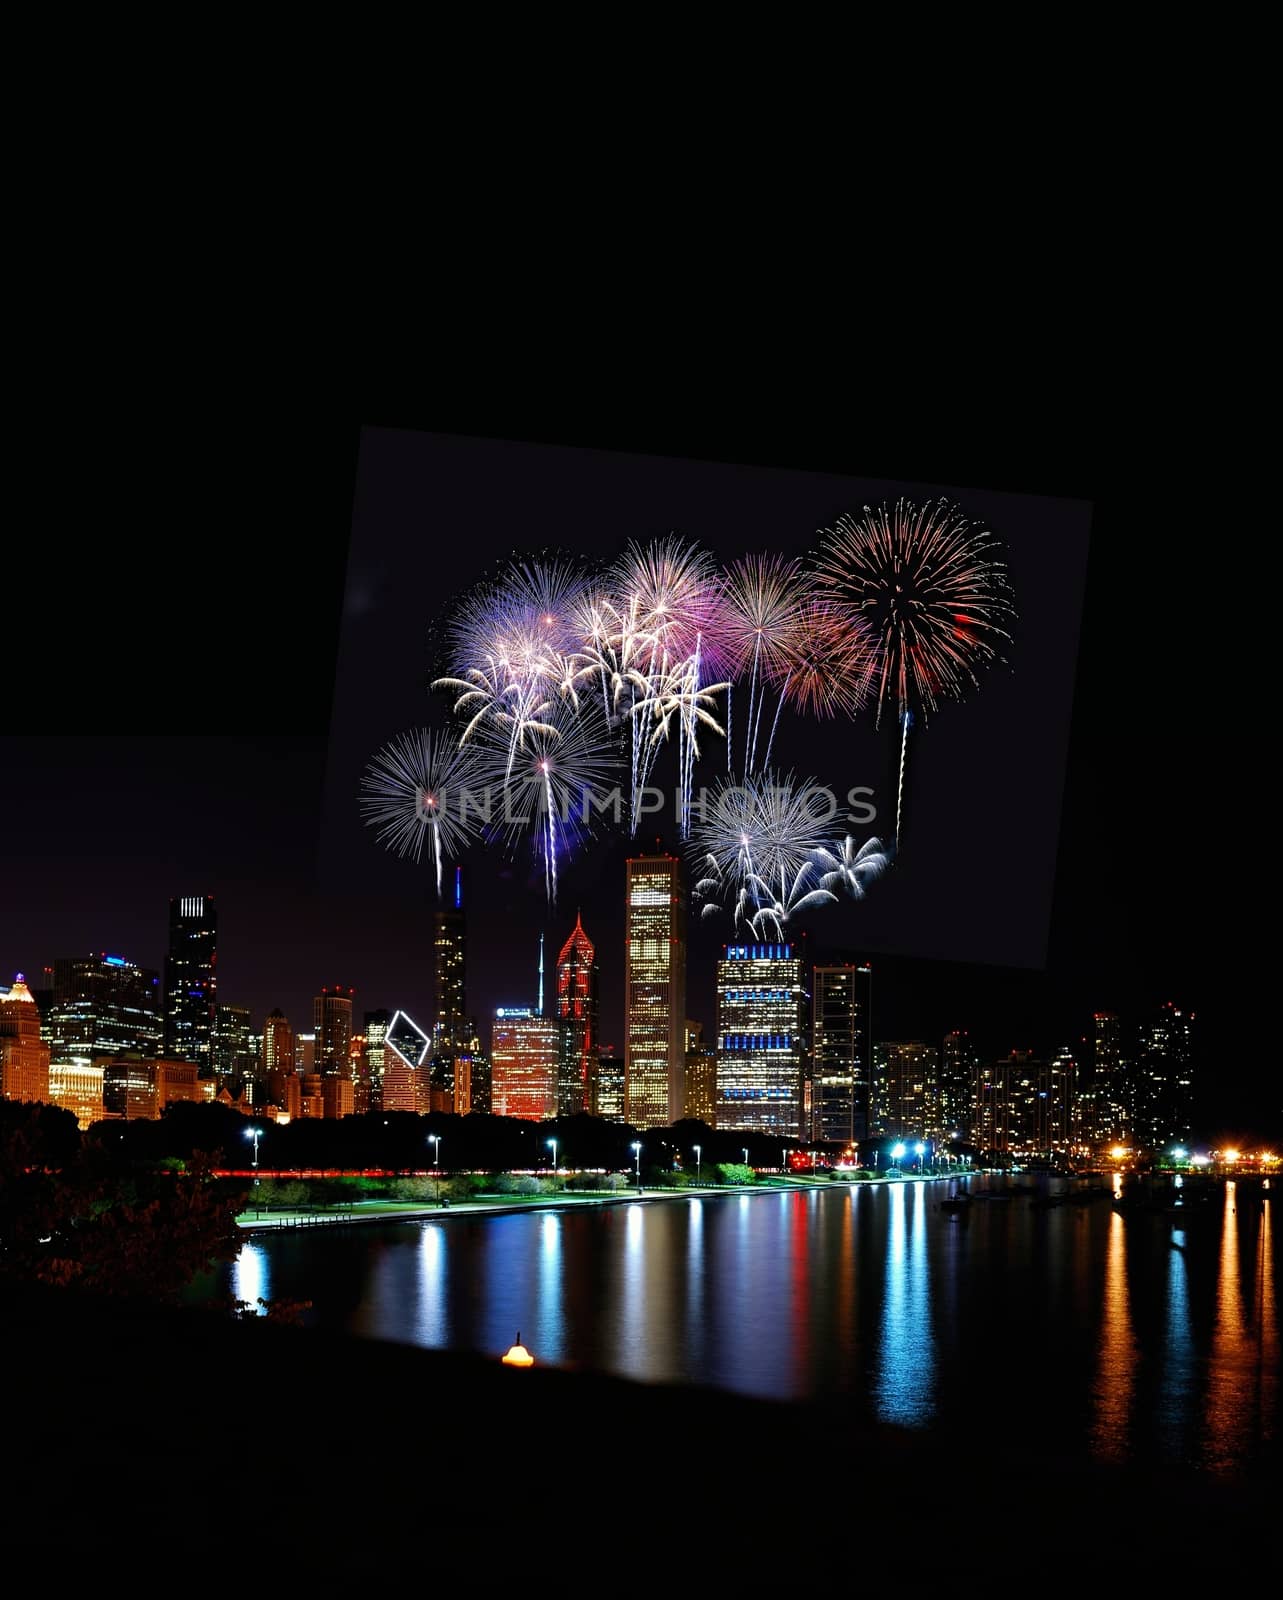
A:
816 499 1014 846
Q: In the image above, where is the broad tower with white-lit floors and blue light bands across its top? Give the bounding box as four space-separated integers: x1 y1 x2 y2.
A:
717 944 811 1139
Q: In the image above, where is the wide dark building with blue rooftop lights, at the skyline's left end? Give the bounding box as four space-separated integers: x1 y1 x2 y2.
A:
50 955 162 1062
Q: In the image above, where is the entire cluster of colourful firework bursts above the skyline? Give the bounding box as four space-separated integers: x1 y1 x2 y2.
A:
362 501 1014 915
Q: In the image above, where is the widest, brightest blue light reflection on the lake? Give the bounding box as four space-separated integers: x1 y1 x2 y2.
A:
877 1182 936 1427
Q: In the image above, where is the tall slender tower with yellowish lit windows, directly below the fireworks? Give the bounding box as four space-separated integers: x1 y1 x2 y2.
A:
624 856 686 1128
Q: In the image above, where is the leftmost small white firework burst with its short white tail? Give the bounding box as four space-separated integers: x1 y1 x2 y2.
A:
360 728 483 894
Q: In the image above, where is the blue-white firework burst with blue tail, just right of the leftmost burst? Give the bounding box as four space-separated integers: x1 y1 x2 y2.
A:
475 699 619 904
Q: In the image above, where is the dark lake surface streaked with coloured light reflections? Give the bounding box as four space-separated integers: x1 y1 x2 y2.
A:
203 1179 1278 1472
